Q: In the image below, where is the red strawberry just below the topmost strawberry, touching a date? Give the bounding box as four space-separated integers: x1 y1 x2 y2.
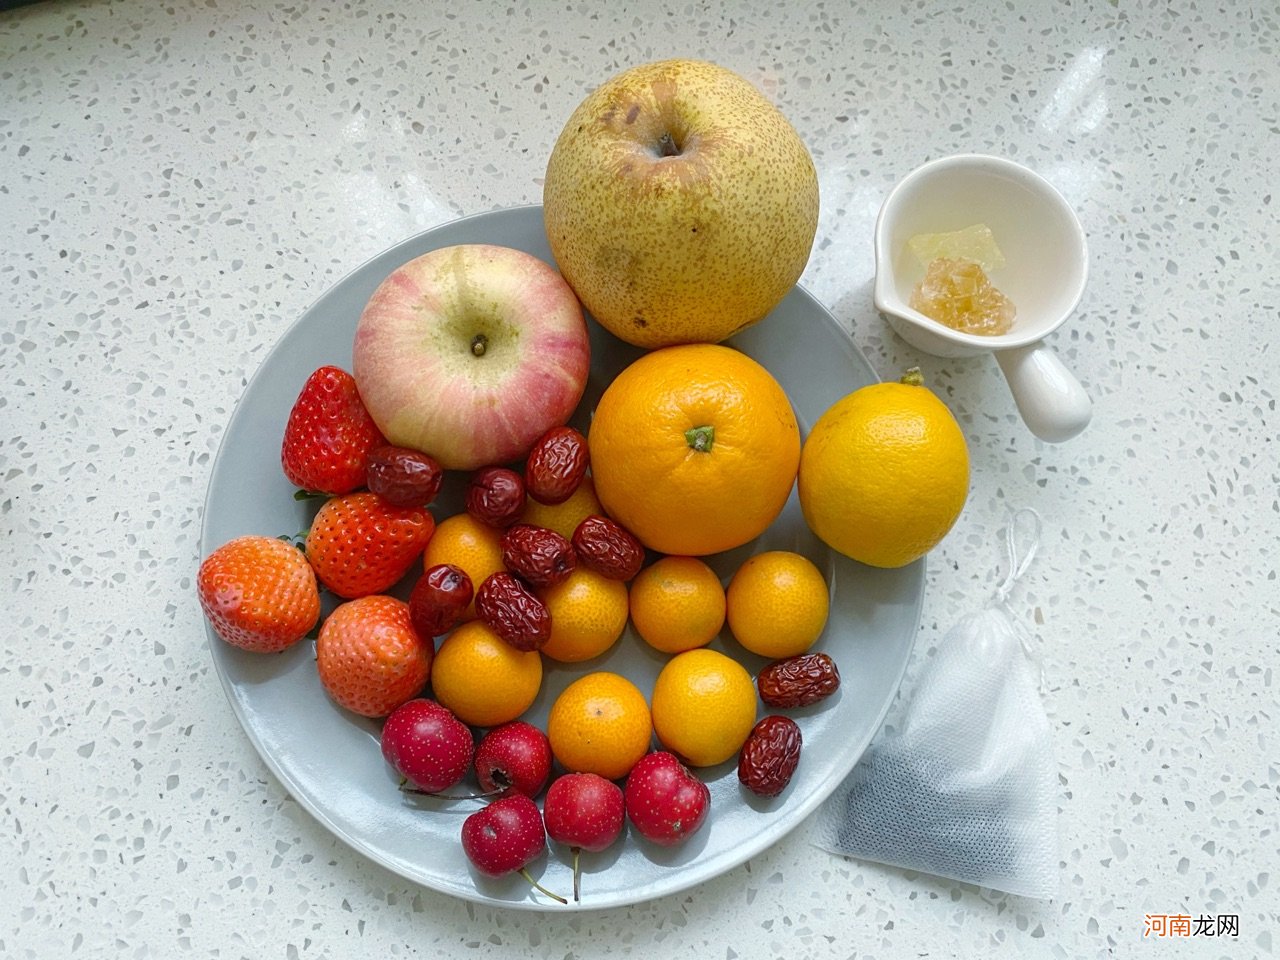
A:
306 492 435 599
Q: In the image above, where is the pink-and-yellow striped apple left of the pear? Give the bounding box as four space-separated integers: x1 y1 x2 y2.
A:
352 243 591 470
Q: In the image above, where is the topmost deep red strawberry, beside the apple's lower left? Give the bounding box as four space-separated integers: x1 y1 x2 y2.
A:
280 366 387 494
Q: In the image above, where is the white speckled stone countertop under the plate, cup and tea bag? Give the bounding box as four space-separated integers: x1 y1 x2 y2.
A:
0 0 1280 960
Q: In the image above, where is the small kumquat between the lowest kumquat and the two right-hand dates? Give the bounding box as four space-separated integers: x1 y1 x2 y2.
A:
653 649 755 767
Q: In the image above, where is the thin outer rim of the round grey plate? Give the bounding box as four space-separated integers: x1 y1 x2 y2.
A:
197 204 927 913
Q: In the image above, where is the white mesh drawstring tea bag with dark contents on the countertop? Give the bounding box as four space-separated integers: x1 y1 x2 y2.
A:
814 509 1059 900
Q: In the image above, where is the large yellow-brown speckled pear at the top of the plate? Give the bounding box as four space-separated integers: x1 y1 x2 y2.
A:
543 60 818 348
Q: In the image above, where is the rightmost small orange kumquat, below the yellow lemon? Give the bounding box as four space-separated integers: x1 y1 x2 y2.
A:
724 550 831 659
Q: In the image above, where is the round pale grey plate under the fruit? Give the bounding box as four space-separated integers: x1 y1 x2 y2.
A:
201 206 924 910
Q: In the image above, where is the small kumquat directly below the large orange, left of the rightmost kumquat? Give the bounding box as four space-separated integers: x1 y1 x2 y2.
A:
631 557 724 653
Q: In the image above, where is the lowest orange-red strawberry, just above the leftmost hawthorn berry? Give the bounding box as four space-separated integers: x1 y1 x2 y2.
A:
316 594 434 717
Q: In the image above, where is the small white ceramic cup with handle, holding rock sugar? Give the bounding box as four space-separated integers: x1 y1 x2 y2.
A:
874 154 1093 443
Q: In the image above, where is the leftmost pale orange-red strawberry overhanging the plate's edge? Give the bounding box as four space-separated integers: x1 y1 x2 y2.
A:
196 536 320 653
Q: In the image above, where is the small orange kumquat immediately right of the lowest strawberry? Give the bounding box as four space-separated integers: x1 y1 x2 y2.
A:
431 620 543 727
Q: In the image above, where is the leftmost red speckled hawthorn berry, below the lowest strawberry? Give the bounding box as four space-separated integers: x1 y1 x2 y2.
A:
383 699 475 794
